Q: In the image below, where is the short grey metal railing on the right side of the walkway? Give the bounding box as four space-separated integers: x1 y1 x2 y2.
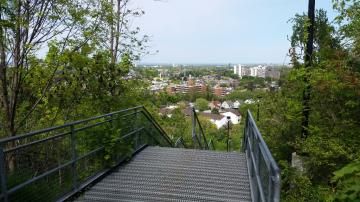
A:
243 110 280 202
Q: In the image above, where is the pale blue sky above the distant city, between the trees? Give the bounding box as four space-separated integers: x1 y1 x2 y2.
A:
132 0 335 64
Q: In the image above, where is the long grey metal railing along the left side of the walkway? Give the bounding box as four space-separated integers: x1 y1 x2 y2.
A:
0 106 174 202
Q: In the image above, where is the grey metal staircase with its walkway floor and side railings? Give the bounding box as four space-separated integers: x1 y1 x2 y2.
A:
0 106 280 202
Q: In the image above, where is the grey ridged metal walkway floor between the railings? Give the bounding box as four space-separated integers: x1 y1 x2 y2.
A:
78 147 251 201
